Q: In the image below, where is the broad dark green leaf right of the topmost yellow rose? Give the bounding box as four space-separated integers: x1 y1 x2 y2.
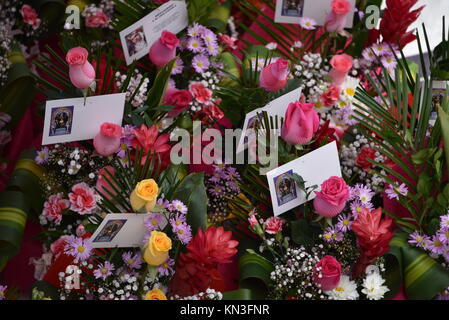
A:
171 173 207 233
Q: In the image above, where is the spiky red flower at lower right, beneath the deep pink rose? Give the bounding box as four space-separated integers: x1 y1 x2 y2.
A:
352 208 393 278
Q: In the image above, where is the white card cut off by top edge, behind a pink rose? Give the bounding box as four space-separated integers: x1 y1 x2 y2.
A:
274 0 355 28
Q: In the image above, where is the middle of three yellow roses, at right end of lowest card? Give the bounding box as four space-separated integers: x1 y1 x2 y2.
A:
143 231 171 267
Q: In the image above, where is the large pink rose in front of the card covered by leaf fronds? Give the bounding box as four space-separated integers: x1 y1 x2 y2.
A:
281 101 320 144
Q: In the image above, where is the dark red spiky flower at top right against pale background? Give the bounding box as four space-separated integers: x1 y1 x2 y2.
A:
371 0 425 49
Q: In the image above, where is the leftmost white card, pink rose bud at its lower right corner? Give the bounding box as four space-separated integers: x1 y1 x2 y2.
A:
42 93 126 145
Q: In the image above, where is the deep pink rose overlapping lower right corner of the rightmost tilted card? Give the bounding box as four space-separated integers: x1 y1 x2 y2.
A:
313 177 349 218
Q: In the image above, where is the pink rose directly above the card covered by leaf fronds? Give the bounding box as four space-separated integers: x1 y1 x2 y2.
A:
259 59 289 92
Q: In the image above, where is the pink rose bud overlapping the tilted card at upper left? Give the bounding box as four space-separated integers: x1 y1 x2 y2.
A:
150 30 179 67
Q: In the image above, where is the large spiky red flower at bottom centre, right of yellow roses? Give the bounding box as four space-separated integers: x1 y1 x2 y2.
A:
170 226 239 296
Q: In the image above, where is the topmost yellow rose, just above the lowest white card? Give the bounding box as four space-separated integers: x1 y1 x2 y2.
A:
129 179 159 212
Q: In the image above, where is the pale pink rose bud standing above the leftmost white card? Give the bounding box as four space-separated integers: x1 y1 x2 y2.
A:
65 47 95 89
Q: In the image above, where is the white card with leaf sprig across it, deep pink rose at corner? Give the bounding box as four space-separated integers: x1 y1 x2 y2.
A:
267 141 341 216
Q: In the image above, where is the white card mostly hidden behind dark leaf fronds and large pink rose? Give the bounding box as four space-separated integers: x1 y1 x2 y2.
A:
237 88 301 153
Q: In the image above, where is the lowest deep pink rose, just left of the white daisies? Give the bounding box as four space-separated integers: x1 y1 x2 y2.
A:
313 256 341 291
